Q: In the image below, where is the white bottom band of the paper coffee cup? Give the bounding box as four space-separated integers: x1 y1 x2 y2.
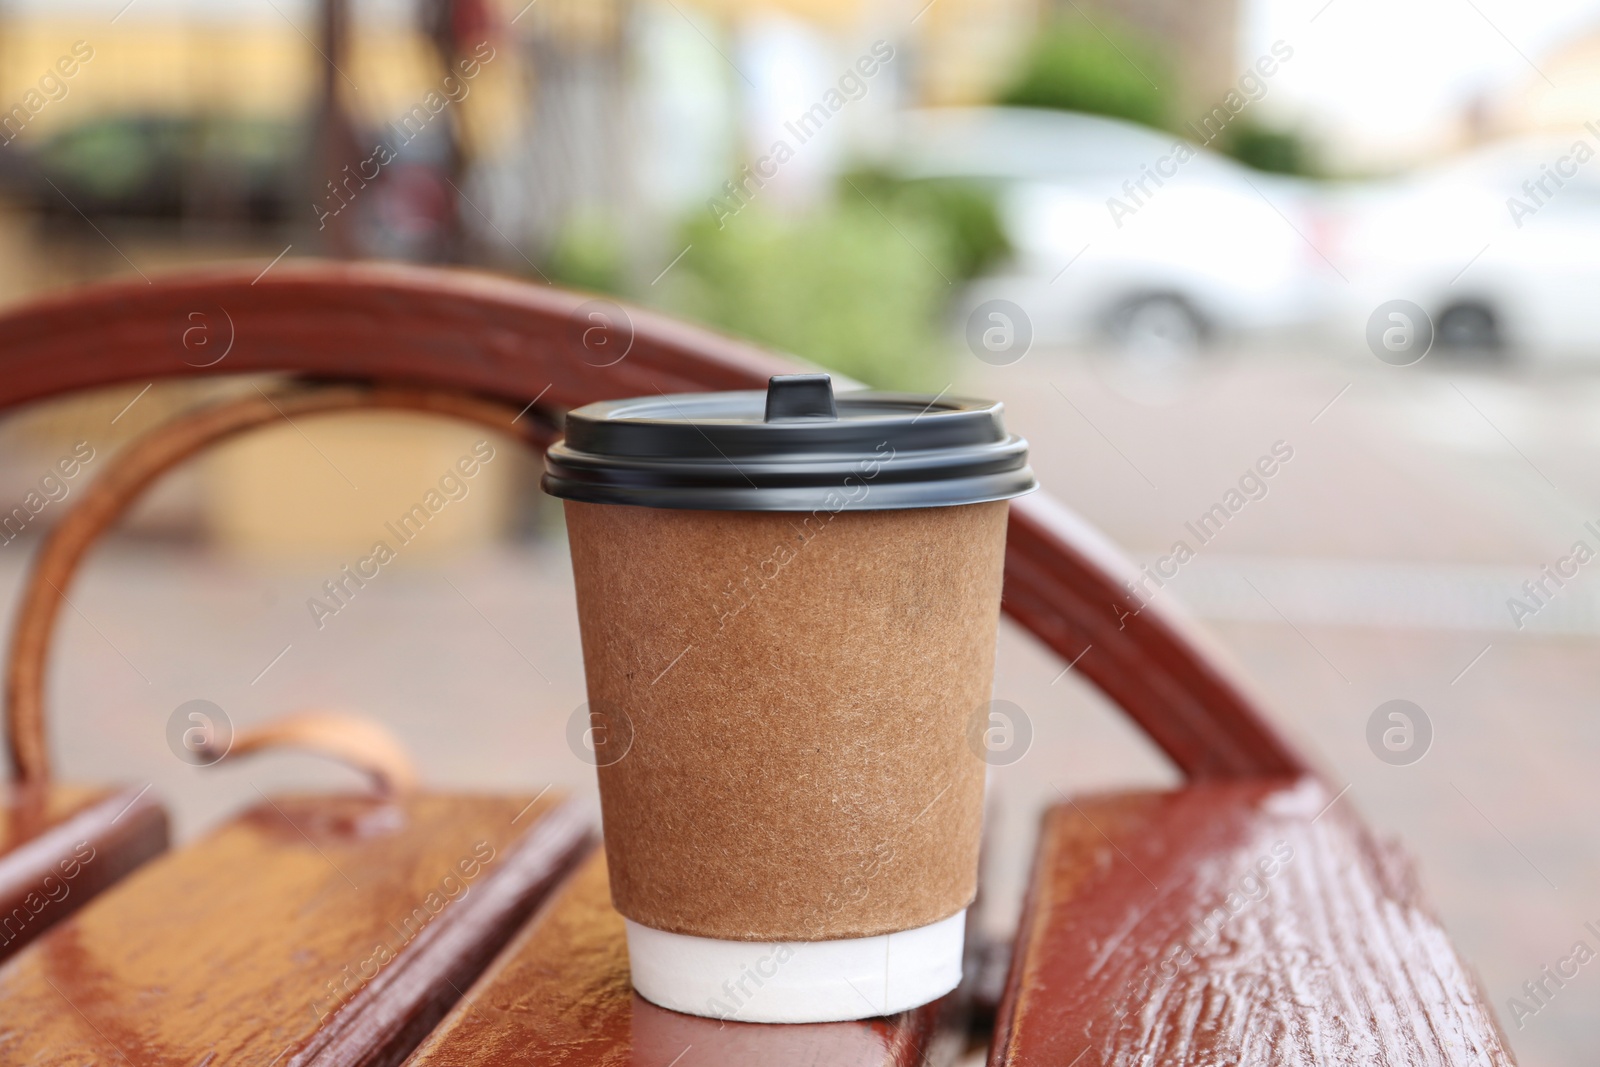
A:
624 909 966 1022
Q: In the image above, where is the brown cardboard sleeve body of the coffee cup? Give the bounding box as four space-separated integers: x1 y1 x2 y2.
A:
565 501 1008 942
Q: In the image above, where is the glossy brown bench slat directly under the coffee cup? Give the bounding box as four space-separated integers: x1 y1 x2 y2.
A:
406 851 962 1067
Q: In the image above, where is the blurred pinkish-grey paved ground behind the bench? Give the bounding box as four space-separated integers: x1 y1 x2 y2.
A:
0 352 1600 1067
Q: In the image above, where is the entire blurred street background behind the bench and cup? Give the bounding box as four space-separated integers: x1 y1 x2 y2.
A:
0 0 1600 1067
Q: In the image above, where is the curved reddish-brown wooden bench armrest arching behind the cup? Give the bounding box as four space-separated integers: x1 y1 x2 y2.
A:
0 262 1306 779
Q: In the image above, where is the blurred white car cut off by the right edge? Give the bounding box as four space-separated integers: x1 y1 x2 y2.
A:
1330 131 1600 357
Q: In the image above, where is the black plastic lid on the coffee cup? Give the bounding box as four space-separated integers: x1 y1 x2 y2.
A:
542 374 1038 512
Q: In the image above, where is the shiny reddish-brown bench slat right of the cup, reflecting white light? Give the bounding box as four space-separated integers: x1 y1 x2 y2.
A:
989 779 1512 1067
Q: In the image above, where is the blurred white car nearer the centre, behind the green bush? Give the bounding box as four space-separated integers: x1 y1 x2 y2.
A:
894 109 1338 350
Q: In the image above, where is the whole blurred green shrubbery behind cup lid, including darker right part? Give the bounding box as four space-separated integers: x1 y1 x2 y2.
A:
542 170 1010 390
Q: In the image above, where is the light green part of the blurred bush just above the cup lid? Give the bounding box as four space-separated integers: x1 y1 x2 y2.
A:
659 192 955 390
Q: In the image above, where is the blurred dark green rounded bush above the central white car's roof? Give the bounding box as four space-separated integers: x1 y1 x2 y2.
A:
998 19 1174 128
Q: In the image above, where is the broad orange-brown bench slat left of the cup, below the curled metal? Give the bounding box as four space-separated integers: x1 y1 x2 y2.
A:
0 793 589 1067
